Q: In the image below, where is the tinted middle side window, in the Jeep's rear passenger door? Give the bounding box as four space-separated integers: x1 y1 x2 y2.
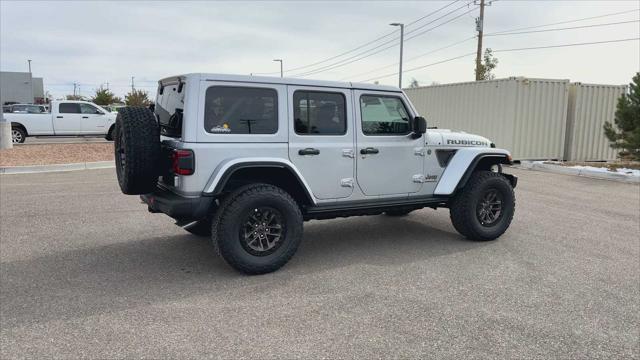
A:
293 91 347 135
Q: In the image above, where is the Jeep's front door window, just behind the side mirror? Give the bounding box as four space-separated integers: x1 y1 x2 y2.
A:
360 95 411 135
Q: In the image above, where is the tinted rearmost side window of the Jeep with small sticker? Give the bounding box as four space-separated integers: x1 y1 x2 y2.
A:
204 86 278 134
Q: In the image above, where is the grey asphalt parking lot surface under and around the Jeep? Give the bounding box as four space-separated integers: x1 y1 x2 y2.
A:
0 169 640 359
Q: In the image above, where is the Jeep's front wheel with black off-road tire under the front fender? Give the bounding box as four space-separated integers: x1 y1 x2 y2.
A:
449 171 515 241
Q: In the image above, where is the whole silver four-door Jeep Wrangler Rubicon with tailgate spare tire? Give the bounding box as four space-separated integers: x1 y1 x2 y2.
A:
114 74 517 274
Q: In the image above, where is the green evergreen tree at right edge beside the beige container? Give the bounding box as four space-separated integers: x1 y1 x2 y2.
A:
604 72 640 160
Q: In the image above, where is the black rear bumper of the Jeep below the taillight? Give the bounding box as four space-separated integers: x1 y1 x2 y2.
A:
140 188 214 220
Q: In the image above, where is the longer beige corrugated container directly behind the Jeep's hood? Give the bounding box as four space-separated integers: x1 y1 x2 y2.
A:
405 78 569 159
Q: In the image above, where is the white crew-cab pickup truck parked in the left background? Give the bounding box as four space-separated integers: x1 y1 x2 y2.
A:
4 100 117 143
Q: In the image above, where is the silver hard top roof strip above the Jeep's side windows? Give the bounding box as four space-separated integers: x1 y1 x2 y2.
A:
158 73 402 92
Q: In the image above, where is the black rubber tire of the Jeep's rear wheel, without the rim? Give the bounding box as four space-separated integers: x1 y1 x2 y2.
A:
212 184 303 274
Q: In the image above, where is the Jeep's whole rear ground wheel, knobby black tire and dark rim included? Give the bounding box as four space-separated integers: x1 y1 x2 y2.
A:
212 184 303 274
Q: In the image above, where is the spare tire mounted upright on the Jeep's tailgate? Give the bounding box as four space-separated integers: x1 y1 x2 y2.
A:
114 107 161 195
